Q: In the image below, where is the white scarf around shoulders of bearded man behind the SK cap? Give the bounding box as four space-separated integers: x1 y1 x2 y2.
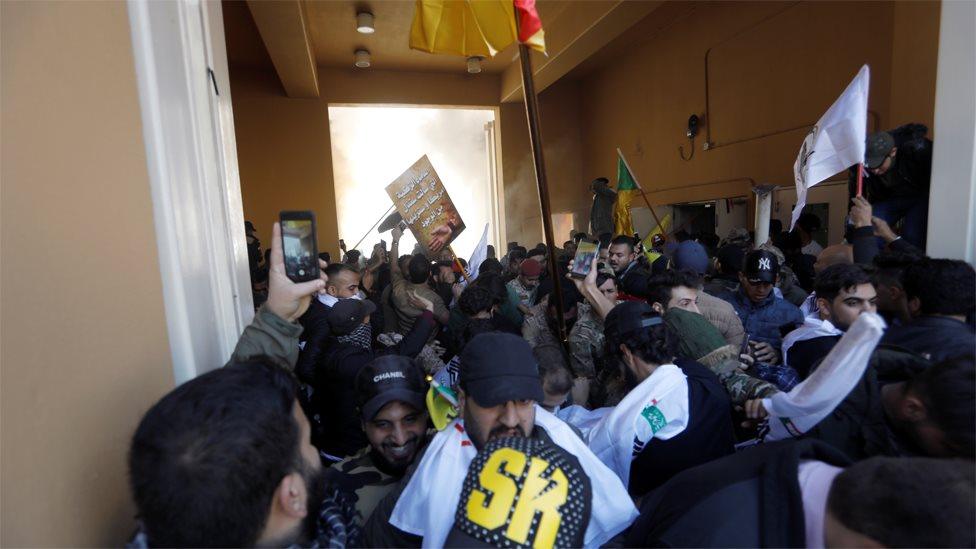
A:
390 405 638 547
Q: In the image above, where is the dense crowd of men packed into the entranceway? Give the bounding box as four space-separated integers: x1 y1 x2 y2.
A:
129 128 976 547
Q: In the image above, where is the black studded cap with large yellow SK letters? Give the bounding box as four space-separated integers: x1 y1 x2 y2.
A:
444 437 593 547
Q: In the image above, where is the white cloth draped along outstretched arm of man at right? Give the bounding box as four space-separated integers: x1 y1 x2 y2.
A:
763 313 885 441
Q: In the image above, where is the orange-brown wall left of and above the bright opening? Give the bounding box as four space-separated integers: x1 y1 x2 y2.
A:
230 67 499 257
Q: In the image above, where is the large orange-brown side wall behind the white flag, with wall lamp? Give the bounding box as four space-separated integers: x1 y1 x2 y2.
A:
582 2 893 219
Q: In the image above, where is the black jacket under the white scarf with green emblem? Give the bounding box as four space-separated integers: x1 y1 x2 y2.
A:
627 359 735 496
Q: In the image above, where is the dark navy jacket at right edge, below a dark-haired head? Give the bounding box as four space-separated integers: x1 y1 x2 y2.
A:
881 316 976 364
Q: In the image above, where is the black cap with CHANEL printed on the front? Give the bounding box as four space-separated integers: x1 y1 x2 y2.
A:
355 355 427 421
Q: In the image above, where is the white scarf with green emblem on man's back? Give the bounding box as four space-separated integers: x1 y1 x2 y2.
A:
589 364 690 486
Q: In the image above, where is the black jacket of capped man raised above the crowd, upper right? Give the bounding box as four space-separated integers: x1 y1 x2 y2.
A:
848 124 932 203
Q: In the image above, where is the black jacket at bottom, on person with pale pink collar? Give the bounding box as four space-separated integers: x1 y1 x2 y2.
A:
626 440 849 547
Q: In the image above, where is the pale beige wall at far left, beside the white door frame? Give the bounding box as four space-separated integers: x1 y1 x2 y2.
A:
0 2 173 546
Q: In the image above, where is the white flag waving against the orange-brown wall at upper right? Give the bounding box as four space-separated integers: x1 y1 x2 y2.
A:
790 65 871 231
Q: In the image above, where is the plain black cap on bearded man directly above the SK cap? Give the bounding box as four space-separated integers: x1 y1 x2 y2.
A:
459 332 545 408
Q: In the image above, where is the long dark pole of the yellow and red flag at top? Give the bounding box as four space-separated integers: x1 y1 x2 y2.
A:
519 42 566 344
